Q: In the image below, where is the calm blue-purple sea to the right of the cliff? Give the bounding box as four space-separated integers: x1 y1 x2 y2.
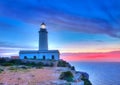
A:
70 61 120 85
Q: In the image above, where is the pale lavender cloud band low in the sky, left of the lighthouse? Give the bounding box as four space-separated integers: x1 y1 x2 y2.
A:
0 41 36 56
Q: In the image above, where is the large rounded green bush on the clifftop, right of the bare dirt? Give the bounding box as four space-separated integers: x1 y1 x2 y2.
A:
59 71 73 82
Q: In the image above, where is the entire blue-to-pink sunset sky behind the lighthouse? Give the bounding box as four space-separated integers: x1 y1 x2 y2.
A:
0 0 120 62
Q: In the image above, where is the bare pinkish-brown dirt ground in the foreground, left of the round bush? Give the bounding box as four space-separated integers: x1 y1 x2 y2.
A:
0 67 60 85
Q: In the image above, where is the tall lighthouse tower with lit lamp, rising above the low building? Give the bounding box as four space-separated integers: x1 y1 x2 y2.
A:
39 23 48 50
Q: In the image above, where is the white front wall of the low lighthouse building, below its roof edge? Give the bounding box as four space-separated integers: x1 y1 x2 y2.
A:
20 53 59 60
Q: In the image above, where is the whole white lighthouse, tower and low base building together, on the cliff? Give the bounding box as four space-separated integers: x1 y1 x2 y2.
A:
19 23 59 60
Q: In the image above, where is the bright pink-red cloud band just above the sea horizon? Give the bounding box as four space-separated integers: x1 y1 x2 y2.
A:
61 51 120 62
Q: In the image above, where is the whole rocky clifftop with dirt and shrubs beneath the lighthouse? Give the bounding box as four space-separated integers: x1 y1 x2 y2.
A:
0 60 92 85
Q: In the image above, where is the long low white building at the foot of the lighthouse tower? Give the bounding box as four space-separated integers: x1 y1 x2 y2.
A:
20 50 59 60
